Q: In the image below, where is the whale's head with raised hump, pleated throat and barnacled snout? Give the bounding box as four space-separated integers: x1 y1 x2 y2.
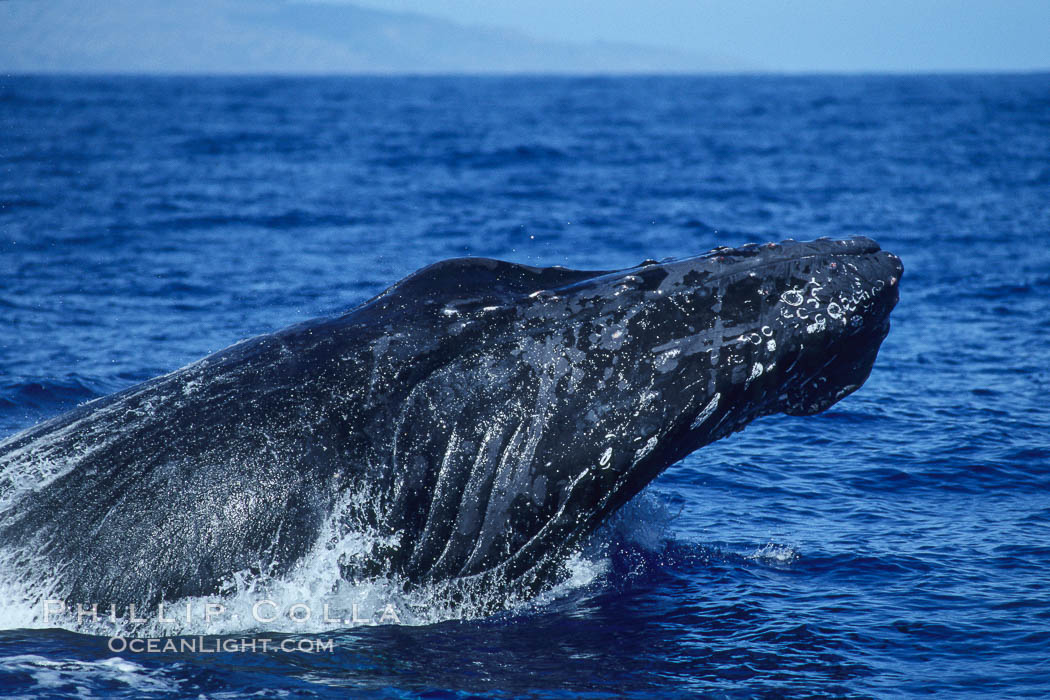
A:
354 238 901 590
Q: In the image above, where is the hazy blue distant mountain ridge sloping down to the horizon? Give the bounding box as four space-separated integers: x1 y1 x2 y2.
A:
0 0 744 75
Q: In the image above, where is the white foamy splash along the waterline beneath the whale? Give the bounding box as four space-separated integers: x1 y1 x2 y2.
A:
0 492 673 637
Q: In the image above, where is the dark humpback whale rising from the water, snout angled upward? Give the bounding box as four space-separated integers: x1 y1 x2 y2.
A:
0 238 902 610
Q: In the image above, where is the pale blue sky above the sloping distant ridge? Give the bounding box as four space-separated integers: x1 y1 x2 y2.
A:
346 0 1050 71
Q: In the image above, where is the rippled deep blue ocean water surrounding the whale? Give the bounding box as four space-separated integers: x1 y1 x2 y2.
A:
0 75 1050 698
